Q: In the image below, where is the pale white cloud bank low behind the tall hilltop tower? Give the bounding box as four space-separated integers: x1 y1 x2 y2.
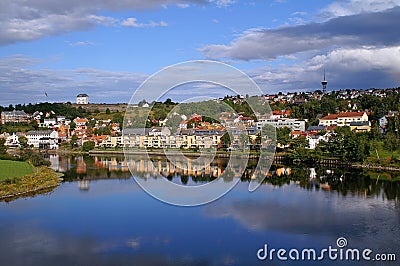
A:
253 46 400 92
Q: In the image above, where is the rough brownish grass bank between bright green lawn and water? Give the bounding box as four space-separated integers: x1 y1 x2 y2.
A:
0 166 61 201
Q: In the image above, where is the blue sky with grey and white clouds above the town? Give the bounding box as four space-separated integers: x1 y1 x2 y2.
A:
0 0 400 106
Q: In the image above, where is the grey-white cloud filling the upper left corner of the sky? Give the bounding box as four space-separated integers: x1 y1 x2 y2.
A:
0 0 217 45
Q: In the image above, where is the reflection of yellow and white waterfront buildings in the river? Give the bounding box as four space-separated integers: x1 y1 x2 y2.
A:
50 155 291 180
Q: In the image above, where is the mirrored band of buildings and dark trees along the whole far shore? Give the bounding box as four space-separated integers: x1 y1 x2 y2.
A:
54 156 400 200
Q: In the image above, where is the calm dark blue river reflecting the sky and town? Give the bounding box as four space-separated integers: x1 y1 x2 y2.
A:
0 157 400 265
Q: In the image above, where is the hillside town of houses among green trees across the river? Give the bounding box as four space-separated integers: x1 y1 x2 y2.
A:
0 86 400 163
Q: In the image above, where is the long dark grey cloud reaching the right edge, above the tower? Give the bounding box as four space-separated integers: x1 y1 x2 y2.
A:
200 7 400 60
